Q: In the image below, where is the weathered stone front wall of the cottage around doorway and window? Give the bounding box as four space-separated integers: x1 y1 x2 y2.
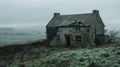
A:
50 27 94 47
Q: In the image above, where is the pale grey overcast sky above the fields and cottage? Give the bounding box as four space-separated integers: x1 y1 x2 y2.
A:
0 0 120 30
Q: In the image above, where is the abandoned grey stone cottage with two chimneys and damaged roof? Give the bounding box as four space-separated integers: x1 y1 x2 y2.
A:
46 10 105 47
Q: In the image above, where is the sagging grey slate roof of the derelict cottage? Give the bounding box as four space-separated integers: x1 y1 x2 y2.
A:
47 13 104 27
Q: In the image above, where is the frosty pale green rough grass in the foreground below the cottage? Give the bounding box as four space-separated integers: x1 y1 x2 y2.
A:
7 46 120 67
